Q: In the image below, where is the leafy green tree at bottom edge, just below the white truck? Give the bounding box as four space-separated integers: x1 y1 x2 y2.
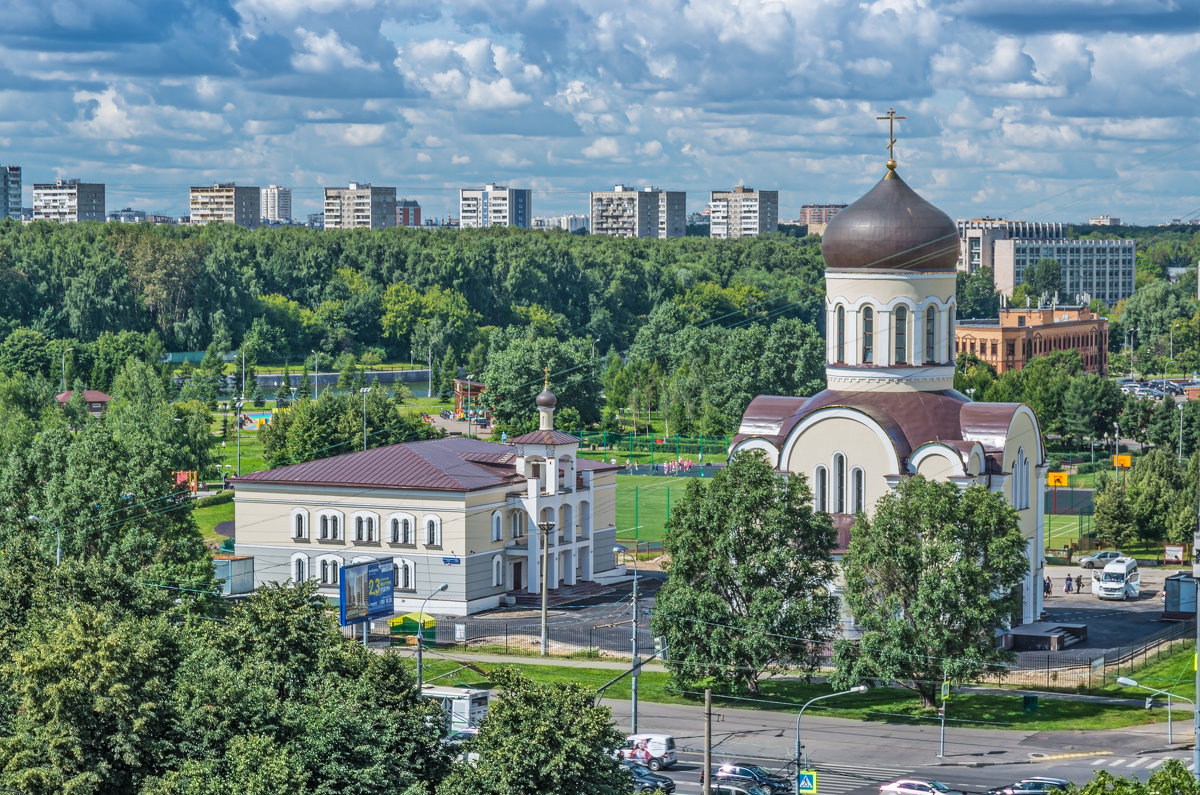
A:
437 669 630 795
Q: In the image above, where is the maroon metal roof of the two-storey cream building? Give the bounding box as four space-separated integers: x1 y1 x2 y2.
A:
233 435 619 491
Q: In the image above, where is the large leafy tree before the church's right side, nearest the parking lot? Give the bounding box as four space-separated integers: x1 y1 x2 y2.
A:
830 476 1030 706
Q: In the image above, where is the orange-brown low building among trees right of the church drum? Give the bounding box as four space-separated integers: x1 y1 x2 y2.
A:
954 306 1109 376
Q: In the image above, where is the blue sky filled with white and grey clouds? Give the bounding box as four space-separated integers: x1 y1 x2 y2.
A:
0 0 1200 225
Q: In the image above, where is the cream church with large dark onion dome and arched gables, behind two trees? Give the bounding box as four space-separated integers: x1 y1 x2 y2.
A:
730 161 1049 635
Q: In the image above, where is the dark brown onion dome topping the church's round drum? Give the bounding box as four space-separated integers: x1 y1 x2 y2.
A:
821 161 959 271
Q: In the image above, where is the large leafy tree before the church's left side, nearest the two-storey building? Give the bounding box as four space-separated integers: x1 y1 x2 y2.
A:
650 452 838 693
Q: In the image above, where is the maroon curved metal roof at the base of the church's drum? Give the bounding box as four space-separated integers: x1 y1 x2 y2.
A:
733 389 1021 473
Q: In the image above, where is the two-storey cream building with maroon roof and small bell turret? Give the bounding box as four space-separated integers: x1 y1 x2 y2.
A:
234 389 623 615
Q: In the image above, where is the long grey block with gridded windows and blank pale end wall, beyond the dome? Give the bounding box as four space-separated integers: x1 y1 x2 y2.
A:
992 239 1138 306
